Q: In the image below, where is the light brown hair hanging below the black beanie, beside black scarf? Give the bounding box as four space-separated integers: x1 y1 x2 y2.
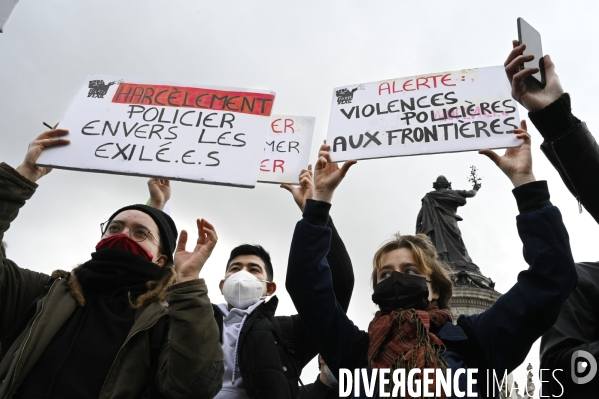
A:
52 265 177 309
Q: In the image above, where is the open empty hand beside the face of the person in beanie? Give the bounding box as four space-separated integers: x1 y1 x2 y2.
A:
175 219 218 283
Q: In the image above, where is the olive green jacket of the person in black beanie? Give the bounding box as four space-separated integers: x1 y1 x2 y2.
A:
0 163 224 399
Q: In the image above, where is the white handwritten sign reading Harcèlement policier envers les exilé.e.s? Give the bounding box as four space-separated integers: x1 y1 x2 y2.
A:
38 75 275 187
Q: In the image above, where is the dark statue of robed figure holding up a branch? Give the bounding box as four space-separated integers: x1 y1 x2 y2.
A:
416 166 481 273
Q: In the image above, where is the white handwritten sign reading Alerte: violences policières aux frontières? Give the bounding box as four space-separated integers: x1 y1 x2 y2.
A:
327 66 521 161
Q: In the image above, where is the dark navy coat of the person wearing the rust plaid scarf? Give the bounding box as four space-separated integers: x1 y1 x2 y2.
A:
286 182 576 398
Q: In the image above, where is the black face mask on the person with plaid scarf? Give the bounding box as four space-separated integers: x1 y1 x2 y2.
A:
372 272 430 312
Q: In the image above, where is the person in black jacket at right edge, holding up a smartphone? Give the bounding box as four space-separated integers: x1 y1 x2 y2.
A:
505 41 599 399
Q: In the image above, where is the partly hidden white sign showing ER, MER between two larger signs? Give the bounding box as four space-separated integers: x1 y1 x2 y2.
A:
258 115 315 184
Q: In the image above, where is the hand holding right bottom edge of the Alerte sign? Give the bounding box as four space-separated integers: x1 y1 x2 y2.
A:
478 120 536 187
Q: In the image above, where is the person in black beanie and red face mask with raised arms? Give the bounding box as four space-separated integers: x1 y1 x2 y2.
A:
0 129 223 399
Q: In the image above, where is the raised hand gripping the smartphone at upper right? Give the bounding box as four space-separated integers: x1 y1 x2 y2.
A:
504 40 564 111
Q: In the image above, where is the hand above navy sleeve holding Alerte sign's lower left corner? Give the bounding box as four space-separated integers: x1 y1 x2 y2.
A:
314 144 358 203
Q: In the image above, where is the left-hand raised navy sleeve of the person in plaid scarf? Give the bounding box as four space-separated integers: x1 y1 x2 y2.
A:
285 200 366 377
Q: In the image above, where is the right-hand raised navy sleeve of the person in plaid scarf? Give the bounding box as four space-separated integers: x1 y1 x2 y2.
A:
458 181 578 375
